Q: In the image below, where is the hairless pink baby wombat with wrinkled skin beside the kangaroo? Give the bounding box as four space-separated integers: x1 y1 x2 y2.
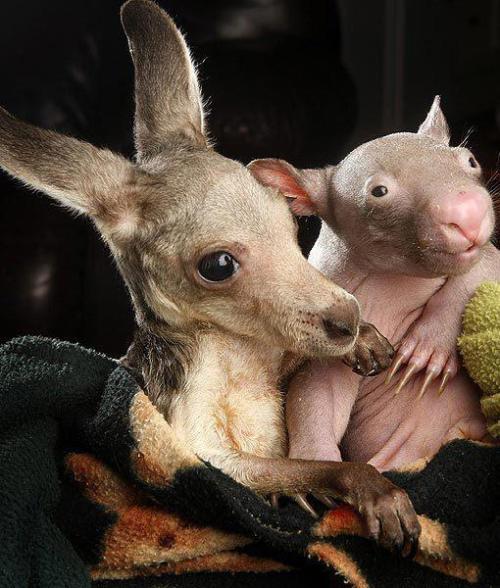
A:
251 98 500 478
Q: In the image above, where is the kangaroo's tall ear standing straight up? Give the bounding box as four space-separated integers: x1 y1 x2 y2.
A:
121 0 206 158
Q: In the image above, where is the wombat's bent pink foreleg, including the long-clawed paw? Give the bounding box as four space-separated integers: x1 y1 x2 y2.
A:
386 243 500 397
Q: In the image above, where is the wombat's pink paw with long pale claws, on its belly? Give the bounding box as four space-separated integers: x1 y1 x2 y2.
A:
385 310 460 398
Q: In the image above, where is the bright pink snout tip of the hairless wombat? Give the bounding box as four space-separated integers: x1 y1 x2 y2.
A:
436 192 490 248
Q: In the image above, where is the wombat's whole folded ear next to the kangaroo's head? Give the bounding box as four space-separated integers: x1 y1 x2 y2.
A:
248 159 328 216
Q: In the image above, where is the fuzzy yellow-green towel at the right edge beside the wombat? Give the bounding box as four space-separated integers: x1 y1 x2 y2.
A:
458 282 500 437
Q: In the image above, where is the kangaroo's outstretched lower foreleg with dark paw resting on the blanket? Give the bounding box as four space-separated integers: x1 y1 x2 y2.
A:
235 454 420 554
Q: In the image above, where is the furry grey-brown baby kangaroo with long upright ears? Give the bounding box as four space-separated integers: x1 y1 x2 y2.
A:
0 0 419 547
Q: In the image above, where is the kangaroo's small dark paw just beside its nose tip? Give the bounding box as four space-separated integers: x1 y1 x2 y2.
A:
342 322 394 376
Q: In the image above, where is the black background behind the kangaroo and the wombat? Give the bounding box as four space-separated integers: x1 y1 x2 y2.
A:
0 0 500 356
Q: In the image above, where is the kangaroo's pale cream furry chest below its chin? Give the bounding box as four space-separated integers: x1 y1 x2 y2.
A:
166 336 287 471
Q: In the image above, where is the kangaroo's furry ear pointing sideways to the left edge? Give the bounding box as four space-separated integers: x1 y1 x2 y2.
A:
0 108 135 234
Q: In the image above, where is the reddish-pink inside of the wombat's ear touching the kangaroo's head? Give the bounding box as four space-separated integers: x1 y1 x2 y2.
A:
248 159 317 216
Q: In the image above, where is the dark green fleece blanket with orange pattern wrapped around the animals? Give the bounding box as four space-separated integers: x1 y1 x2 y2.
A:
0 337 500 588
